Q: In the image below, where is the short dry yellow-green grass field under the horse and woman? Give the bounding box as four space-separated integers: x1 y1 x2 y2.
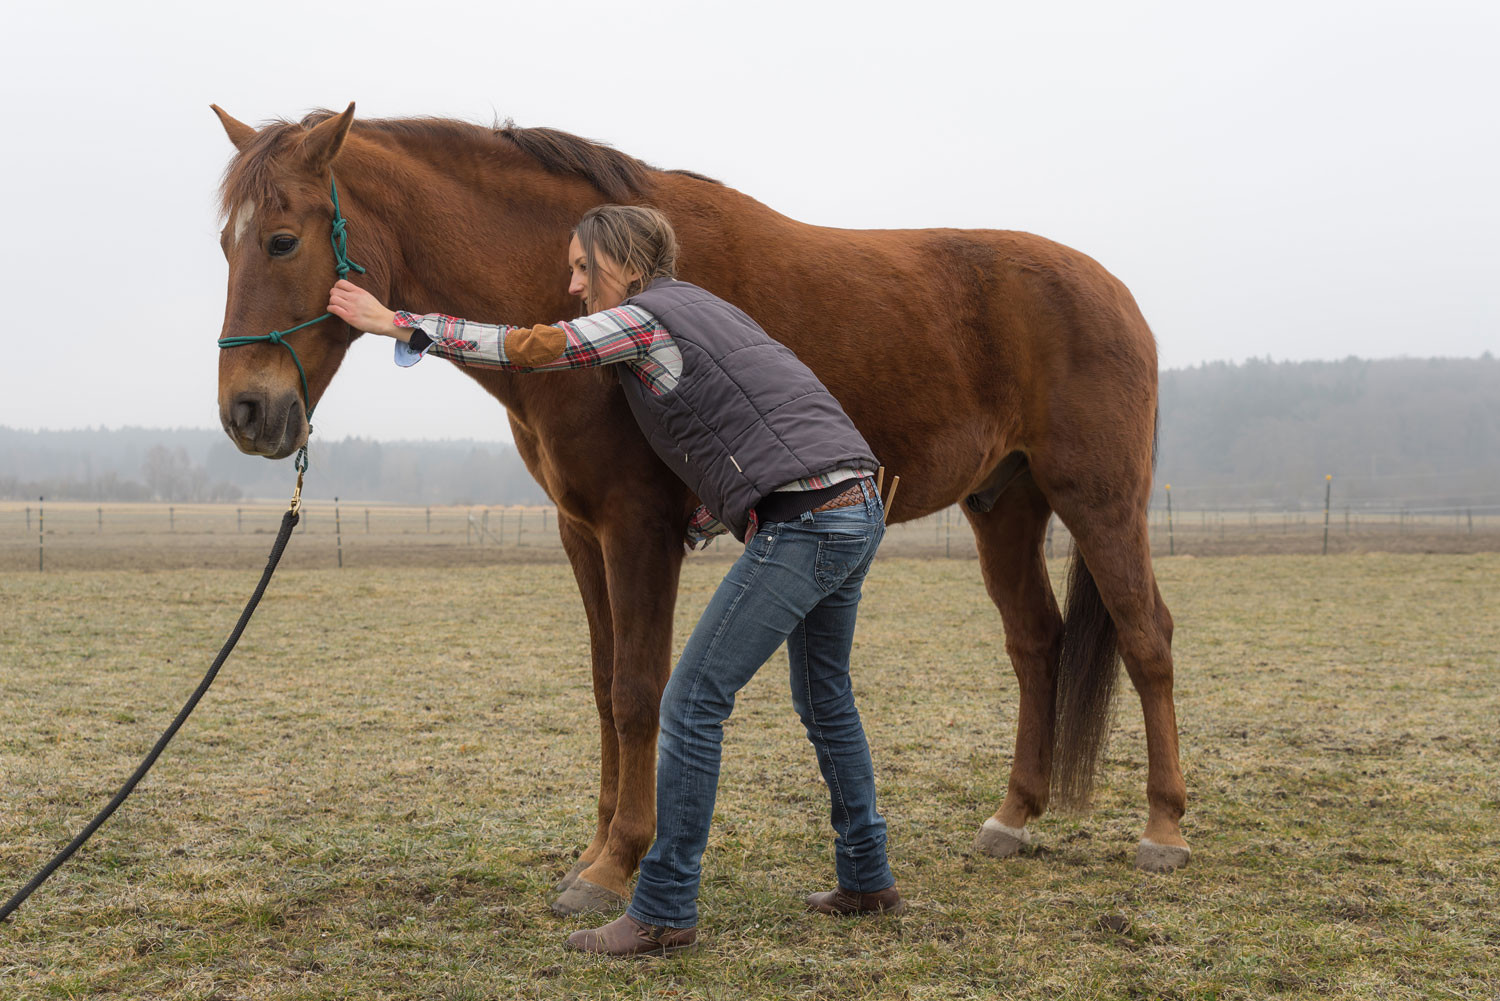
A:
0 552 1500 1001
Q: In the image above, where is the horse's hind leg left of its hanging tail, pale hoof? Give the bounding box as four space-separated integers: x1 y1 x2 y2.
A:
965 471 1062 858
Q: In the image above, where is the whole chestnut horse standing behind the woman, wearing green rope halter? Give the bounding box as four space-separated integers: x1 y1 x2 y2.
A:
215 105 1188 912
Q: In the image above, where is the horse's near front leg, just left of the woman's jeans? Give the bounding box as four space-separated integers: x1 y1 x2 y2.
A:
552 521 683 914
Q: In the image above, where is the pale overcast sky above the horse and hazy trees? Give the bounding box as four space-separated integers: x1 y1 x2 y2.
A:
0 0 1500 440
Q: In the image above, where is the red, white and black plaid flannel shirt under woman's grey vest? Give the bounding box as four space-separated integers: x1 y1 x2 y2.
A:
395 306 860 549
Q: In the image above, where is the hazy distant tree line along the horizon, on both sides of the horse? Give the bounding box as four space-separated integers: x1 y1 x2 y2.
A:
0 353 1500 509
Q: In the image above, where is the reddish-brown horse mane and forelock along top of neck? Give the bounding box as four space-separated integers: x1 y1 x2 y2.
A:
219 108 720 216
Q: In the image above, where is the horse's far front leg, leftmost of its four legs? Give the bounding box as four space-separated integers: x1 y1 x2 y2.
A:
554 513 620 909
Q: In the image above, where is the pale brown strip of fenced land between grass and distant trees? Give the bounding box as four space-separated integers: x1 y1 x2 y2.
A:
0 500 1500 570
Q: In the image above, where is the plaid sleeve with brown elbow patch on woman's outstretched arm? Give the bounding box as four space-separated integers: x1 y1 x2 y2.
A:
395 306 671 372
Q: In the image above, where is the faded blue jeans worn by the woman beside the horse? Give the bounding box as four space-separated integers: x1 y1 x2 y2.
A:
629 480 896 927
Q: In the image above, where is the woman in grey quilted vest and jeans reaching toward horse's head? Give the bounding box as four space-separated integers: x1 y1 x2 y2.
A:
329 206 903 956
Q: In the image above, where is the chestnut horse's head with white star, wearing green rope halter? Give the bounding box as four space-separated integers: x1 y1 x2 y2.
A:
212 104 373 459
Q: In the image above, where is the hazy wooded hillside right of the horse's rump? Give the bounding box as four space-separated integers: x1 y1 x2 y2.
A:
1157 353 1500 507
